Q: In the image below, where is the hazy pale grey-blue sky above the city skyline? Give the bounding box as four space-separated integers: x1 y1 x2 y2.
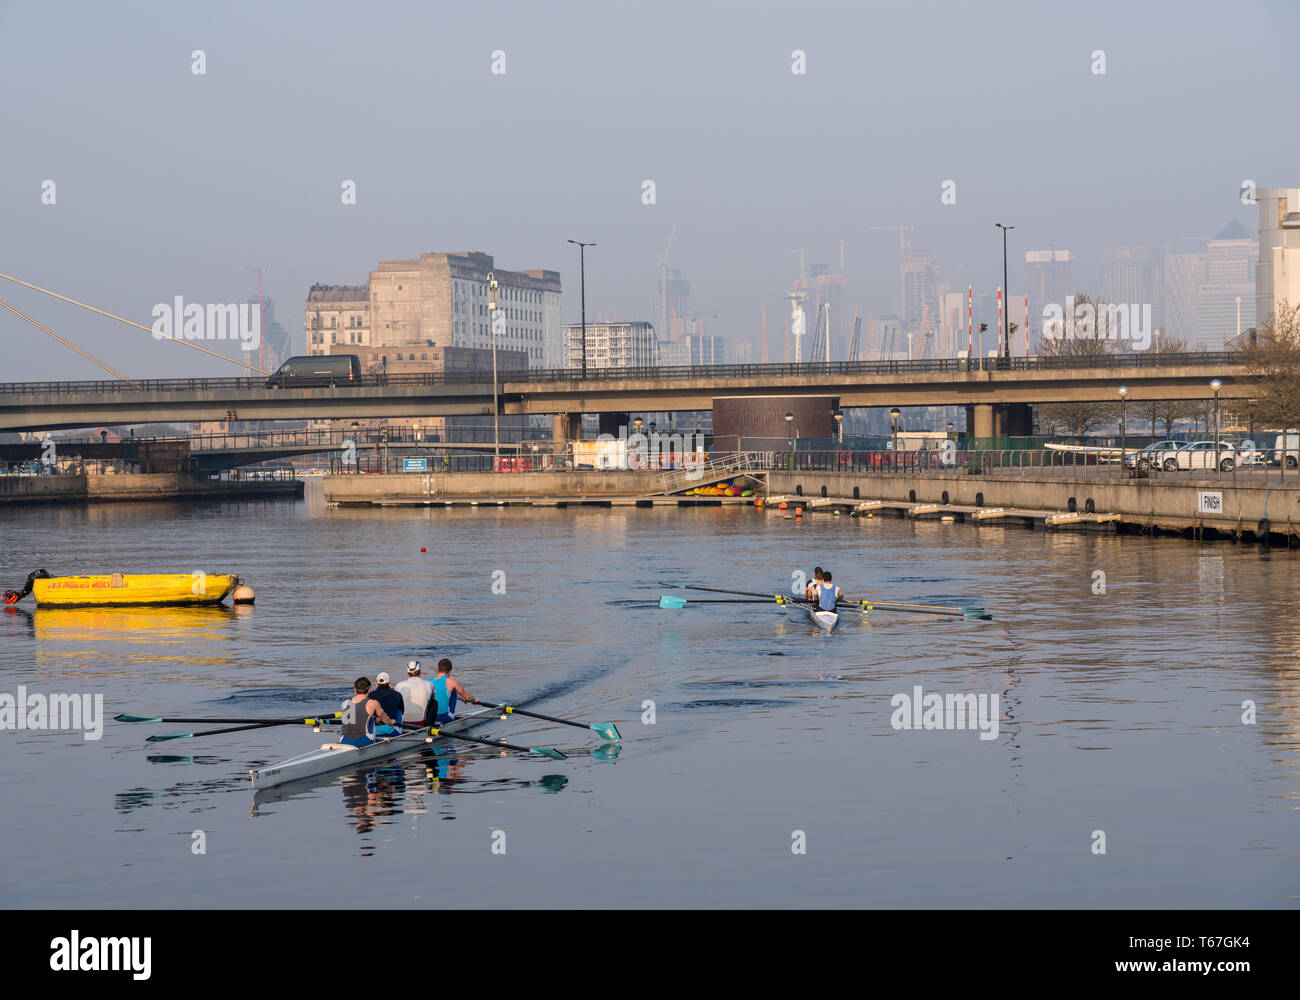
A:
0 0 1300 381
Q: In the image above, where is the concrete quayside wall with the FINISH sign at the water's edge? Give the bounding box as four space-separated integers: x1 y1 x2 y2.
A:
324 469 1300 544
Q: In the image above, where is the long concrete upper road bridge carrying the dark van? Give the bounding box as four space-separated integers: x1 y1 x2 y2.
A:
0 352 1249 441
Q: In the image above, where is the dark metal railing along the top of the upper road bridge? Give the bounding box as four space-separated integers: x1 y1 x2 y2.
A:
0 351 1242 395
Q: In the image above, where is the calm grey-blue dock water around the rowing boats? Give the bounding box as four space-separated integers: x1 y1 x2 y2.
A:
0 481 1300 908
